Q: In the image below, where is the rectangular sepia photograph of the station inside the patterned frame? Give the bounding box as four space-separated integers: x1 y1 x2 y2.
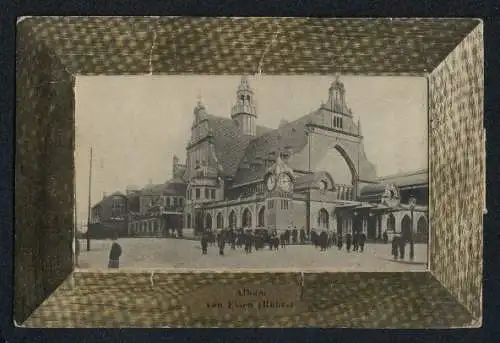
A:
75 74 429 272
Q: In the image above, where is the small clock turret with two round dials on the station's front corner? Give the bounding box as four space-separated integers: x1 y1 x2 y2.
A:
264 156 294 231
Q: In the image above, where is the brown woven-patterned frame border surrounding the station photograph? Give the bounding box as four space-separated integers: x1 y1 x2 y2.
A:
14 17 485 328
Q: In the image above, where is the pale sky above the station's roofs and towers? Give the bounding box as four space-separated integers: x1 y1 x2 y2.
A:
75 75 428 227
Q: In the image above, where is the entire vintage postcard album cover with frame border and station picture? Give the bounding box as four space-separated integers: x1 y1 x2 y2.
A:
14 17 485 329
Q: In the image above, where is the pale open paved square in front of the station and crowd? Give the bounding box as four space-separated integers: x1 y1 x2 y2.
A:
79 238 427 272
